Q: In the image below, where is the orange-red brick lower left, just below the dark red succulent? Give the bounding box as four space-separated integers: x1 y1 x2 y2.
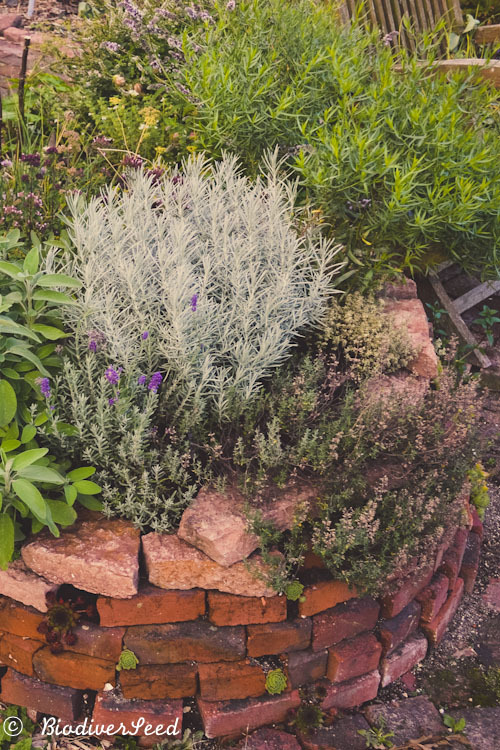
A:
33 648 115 690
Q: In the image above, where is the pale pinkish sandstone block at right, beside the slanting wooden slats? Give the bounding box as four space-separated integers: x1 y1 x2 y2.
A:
384 299 438 379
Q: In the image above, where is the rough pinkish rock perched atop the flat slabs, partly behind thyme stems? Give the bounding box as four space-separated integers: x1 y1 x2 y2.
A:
178 485 318 567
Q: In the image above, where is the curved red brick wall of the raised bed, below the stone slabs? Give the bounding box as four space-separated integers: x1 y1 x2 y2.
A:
0 512 482 737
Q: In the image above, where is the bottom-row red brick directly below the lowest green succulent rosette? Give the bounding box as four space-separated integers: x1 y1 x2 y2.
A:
198 690 300 739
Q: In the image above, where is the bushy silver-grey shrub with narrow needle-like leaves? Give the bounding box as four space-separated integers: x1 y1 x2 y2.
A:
60 156 340 418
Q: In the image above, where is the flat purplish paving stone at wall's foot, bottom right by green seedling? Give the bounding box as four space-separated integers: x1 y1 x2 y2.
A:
364 695 445 745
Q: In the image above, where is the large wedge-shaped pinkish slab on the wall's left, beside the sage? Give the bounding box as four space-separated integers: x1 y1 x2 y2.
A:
21 517 140 599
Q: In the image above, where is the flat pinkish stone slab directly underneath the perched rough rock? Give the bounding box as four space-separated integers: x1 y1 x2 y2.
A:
142 531 276 596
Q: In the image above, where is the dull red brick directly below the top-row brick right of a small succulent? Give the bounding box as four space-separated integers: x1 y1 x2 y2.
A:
312 597 380 651
